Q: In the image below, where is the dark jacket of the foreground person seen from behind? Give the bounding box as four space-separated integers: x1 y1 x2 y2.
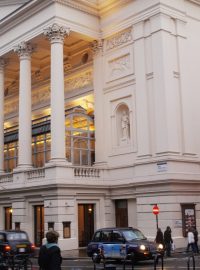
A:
38 244 62 270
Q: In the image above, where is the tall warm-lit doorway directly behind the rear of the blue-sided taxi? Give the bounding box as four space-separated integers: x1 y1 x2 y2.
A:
78 204 94 247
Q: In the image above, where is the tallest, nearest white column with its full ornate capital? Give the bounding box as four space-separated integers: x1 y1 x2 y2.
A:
44 24 70 163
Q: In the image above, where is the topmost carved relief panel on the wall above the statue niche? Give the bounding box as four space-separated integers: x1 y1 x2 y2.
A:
106 28 133 50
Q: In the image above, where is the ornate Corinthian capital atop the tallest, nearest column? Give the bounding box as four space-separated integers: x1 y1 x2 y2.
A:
44 23 70 42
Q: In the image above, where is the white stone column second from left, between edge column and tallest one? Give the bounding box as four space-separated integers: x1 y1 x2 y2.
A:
14 42 32 169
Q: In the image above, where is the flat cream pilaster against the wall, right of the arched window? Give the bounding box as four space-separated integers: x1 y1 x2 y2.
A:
91 40 106 166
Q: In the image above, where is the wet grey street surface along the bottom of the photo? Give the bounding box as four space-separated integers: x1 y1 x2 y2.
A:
30 254 200 270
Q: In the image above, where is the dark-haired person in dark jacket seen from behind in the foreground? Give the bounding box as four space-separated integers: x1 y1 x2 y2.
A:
38 230 62 270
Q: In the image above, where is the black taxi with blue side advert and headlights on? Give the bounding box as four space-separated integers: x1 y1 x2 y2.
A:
87 227 164 261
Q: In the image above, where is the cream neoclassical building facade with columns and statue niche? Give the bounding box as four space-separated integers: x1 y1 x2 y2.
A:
0 0 200 250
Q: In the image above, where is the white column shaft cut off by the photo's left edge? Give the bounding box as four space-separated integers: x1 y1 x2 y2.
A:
0 59 4 173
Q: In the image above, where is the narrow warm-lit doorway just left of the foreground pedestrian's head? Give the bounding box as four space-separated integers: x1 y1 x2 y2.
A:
34 205 44 247
